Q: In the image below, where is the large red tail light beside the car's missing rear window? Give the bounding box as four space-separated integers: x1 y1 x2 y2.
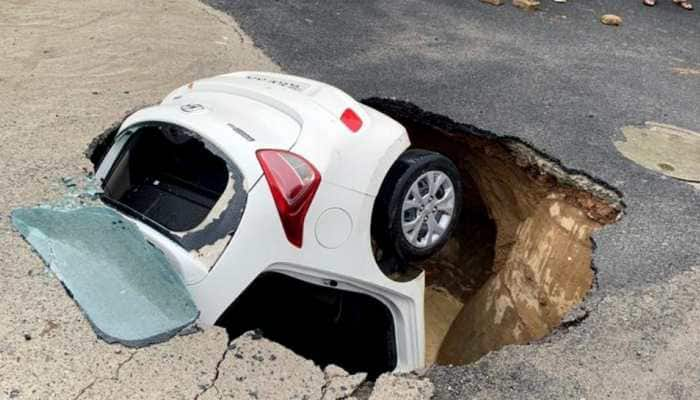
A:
257 150 321 247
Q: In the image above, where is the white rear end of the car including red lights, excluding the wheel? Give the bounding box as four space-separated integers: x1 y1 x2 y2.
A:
97 72 424 376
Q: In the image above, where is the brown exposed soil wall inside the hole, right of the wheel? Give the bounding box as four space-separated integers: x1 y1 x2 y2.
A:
365 99 624 364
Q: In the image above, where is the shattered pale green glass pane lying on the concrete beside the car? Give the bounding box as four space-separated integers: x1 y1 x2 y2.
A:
12 206 199 347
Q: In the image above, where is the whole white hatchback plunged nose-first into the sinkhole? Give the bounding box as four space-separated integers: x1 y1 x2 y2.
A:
96 72 461 375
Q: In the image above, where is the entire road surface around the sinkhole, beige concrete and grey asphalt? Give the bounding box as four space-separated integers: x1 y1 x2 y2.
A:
0 0 700 399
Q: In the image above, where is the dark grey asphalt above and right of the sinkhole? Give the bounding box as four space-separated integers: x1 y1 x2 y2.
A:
198 0 700 399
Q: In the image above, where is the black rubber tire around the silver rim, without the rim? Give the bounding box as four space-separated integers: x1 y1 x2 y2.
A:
372 149 462 262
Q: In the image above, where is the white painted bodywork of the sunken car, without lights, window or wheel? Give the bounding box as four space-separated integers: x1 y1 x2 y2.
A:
96 72 425 371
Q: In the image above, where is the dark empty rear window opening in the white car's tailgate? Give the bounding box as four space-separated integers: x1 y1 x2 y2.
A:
104 124 229 232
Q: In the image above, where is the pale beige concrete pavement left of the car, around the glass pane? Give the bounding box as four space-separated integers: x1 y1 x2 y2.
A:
0 0 277 399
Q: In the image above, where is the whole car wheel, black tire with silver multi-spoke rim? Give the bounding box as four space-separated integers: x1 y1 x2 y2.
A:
372 150 462 261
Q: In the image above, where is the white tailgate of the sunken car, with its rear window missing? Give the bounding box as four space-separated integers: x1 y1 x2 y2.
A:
96 85 301 284
